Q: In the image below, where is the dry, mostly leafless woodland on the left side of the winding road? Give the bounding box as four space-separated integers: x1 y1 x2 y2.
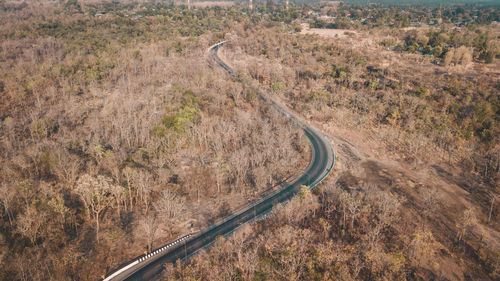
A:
0 1 309 280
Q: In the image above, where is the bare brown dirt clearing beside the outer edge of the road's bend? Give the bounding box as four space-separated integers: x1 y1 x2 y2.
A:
318 124 500 280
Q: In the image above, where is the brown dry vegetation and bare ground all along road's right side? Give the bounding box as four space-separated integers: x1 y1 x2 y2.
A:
171 15 500 280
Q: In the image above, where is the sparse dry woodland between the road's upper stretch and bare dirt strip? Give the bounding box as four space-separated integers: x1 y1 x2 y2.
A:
227 24 500 186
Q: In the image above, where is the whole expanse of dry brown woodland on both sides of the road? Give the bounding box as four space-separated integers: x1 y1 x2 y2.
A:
0 0 500 280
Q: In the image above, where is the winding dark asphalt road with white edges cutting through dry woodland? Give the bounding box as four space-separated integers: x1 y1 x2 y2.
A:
104 42 335 281
